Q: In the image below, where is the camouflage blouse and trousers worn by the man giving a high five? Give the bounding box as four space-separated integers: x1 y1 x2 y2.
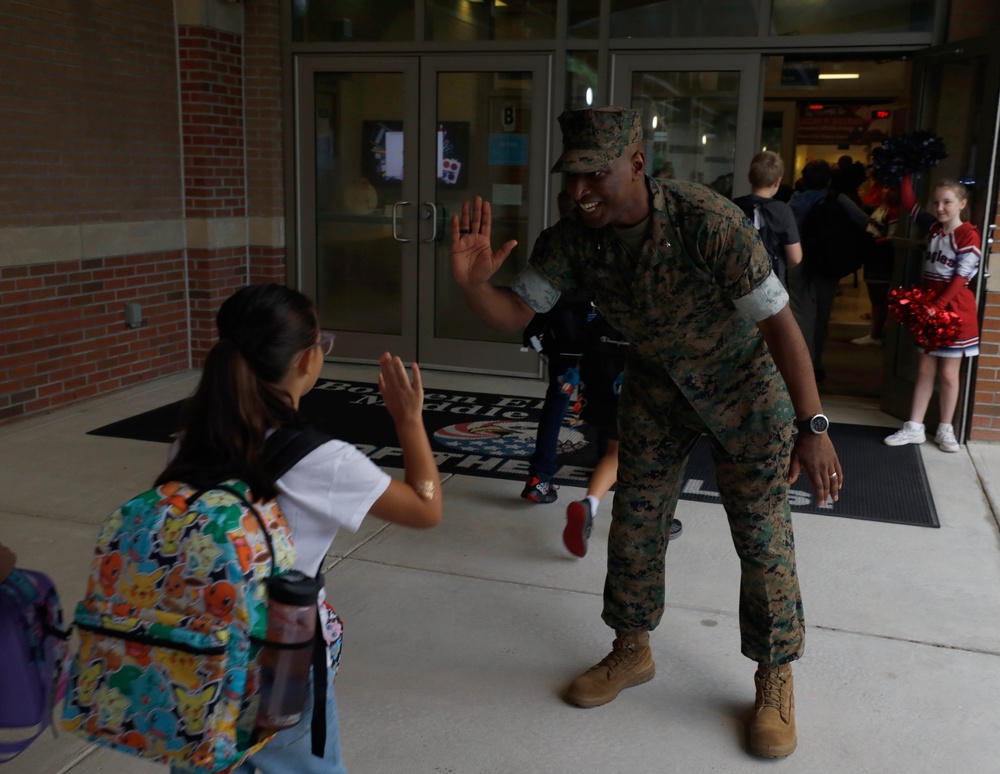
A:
514 177 804 664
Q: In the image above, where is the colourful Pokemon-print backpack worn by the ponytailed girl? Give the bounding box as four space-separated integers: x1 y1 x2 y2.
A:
62 430 328 774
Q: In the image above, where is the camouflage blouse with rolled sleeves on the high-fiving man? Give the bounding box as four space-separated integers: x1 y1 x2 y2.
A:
528 177 793 452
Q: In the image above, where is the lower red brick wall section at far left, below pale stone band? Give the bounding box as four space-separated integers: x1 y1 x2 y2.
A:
0 251 188 421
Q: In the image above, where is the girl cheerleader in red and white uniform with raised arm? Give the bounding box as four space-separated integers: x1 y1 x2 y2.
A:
885 175 982 452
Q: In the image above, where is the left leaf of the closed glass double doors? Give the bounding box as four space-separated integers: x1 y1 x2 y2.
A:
298 59 418 359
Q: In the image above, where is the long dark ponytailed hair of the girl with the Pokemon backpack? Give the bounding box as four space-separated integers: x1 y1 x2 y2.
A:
156 284 319 500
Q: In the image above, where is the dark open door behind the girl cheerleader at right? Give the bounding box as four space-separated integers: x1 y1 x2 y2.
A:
882 39 1000 439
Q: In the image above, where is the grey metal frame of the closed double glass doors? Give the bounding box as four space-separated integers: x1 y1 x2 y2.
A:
289 53 552 378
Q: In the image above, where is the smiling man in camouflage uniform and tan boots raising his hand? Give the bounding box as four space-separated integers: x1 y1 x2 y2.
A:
451 108 843 758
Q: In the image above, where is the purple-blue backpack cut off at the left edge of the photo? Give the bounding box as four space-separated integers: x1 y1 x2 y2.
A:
0 569 69 763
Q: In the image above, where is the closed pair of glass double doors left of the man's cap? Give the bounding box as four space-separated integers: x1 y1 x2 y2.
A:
297 56 549 376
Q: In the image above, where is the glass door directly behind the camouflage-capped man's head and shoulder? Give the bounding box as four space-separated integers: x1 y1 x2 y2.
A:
611 54 760 197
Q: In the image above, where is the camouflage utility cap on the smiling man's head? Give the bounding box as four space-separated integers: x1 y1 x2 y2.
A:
552 107 642 175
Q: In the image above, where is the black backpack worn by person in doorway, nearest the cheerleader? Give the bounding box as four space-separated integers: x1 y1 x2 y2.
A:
800 191 875 279
